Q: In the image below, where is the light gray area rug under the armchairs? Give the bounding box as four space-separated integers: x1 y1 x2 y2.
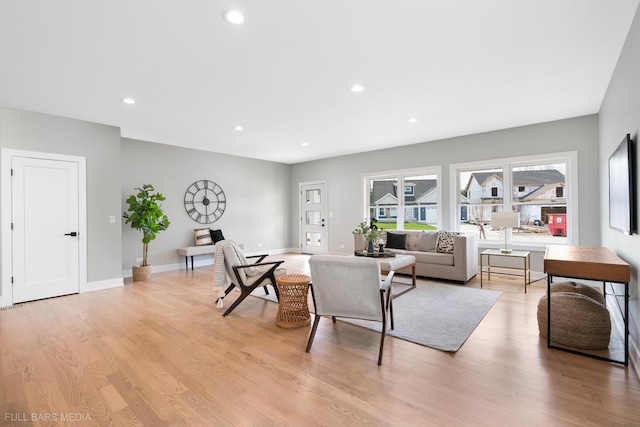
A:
252 282 502 352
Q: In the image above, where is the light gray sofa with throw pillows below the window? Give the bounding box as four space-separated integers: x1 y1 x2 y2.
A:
386 230 478 283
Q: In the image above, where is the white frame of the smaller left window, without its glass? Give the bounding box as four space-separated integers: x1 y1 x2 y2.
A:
360 166 443 230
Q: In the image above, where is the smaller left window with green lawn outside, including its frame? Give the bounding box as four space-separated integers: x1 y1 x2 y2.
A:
363 167 441 230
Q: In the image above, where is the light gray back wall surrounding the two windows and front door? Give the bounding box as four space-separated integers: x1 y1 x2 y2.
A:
289 115 600 271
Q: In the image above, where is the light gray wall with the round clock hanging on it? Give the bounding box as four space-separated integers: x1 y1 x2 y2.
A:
120 138 290 276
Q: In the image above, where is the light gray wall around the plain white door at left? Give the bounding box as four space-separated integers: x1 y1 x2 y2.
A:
0 107 122 288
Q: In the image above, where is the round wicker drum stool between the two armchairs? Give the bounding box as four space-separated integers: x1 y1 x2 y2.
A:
276 274 311 329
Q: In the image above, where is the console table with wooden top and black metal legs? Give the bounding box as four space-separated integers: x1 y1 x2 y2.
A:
544 245 631 366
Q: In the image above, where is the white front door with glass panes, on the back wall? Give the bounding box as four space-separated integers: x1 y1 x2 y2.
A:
300 183 327 254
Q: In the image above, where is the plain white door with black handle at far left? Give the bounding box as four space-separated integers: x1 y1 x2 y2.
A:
11 157 80 303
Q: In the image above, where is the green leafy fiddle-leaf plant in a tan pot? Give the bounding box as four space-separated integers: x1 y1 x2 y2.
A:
122 184 170 280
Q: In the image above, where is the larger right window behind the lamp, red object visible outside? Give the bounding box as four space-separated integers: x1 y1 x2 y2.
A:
451 152 577 246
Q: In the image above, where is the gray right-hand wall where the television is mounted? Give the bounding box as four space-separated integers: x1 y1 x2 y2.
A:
599 5 640 376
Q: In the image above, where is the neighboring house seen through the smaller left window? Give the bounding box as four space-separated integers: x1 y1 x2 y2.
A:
371 179 438 224
